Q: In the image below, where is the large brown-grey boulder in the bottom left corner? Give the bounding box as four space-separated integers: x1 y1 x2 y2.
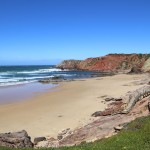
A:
0 130 33 148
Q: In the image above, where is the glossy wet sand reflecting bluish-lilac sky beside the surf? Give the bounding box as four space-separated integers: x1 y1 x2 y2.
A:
0 82 58 105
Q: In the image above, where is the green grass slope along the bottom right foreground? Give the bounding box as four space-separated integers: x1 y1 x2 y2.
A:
0 116 150 150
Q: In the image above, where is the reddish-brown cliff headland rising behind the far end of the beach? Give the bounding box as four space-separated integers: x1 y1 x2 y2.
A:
57 54 150 71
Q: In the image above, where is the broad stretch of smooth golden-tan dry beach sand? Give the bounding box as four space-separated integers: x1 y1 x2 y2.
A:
0 74 146 139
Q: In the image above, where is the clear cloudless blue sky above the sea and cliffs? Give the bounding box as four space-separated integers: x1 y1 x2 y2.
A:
0 0 150 65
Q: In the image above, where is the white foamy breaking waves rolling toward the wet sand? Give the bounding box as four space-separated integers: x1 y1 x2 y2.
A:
0 68 73 86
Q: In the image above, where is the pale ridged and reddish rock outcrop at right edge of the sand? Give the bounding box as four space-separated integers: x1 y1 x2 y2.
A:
92 85 150 117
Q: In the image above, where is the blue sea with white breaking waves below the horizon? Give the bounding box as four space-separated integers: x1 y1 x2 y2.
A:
0 65 93 87
